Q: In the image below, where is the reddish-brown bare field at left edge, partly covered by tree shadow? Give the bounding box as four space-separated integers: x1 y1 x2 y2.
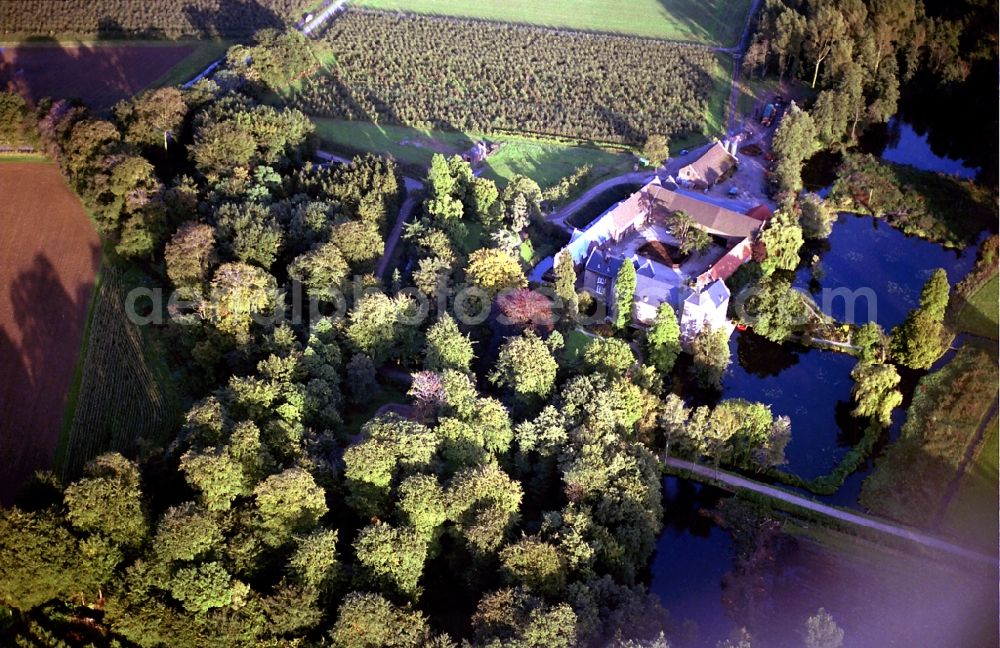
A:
0 161 101 504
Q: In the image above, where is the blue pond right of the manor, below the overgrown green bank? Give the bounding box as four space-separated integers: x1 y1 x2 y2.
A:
795 214 976 331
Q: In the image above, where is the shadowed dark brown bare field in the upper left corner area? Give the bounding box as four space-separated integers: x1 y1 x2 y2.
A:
0 44 194 110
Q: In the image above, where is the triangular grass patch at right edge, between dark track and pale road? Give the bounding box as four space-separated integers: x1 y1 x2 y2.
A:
942 417 1000 550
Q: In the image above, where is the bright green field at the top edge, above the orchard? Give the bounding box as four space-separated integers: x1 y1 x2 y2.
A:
353 0 750 46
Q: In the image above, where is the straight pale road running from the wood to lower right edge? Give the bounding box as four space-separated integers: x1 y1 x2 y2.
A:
667 457 998 565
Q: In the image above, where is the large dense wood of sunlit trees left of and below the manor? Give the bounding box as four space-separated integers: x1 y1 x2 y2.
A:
0 40 820 647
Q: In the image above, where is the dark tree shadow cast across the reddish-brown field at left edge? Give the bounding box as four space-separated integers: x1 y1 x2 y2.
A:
0 245 100 504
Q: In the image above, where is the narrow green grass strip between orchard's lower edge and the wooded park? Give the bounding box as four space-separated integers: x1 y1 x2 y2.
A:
313 118 634 189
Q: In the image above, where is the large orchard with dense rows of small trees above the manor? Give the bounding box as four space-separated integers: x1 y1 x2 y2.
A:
293 10 721 144
